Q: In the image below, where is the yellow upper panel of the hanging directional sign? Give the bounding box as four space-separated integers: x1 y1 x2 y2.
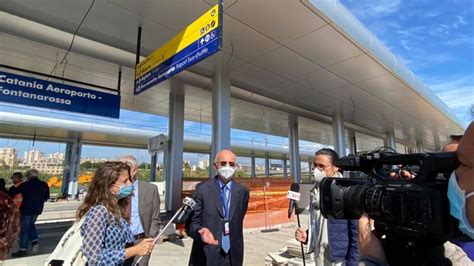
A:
135 5 219 79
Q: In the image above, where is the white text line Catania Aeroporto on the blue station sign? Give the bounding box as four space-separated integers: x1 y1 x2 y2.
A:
0 75 97 100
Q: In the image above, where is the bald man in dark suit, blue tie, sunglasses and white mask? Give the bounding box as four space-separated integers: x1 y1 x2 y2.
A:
187 150 249 266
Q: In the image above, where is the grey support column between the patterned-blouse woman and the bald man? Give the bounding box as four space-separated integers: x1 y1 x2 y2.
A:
165 83 184 211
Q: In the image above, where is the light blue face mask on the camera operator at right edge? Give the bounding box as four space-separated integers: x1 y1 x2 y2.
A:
448 172 474 239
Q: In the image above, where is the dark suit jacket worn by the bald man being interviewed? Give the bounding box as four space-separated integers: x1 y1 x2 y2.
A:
186 178 249 266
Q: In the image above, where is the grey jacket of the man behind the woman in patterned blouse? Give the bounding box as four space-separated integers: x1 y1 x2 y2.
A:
138 180 160 237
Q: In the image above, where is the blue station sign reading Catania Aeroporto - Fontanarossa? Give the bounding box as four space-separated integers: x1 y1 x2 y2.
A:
0 71 120 118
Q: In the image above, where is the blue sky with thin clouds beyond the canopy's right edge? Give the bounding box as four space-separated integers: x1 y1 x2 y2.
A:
340 0 474 124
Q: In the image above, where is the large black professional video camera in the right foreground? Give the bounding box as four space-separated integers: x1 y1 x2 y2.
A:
320 152 459 265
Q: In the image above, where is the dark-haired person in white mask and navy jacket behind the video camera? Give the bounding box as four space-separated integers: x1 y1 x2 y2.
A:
295 148 359 266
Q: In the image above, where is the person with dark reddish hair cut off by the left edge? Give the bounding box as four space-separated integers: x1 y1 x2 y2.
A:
0 192 20 265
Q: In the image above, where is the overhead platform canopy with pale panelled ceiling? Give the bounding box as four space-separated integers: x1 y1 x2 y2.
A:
0 0 463 150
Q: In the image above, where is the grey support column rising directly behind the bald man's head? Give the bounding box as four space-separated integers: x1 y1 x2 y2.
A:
212 52 231 176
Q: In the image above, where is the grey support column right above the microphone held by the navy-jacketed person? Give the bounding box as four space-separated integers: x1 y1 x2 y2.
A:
288 114 301 183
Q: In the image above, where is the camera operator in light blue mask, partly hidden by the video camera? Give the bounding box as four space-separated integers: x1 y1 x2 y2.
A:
359 122 474 266
